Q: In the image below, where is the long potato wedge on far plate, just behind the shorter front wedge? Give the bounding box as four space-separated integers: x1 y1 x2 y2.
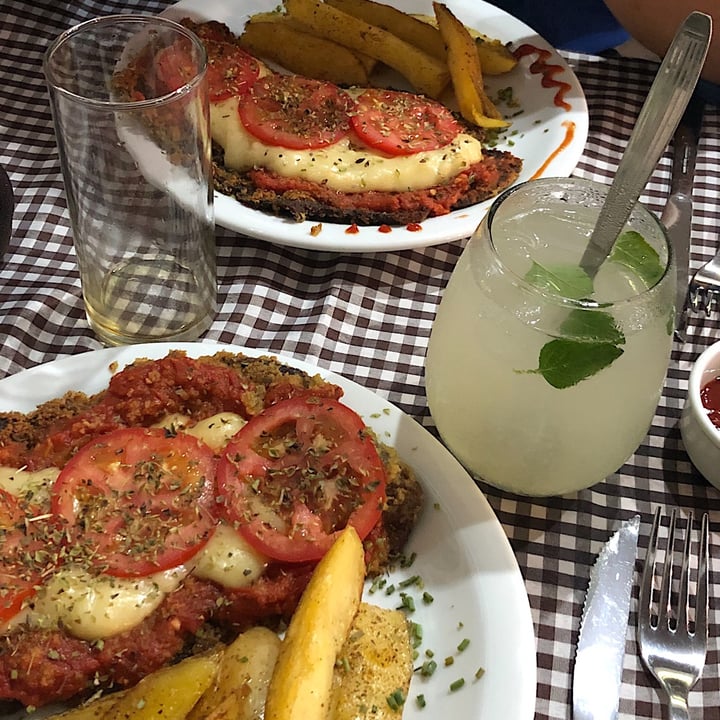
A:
285 0 450 98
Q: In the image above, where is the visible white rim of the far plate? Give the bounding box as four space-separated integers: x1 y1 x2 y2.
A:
162 0 589 253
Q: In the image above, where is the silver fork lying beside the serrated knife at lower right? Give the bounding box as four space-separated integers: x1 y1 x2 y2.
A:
637 509 708 720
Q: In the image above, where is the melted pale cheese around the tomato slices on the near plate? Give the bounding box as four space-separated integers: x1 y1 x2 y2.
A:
0 413 266 641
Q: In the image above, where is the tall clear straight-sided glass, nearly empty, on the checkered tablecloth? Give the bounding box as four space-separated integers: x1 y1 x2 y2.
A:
43 15 217 345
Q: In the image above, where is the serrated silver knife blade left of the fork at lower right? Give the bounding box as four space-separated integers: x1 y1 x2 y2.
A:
573 515 640 720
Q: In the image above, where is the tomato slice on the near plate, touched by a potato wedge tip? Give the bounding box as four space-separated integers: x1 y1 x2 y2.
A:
217 396 385 563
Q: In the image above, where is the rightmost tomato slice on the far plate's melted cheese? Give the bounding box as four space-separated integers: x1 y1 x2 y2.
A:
350 89 461 155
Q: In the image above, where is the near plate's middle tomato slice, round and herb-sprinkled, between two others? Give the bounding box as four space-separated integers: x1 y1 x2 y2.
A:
52 428 217 577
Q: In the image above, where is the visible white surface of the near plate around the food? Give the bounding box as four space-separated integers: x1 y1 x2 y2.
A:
0 343 536 720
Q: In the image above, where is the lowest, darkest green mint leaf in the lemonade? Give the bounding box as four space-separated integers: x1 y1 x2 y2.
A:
535 339 623 390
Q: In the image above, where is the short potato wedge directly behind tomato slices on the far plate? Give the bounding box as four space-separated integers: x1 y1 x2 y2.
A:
239 15 369 87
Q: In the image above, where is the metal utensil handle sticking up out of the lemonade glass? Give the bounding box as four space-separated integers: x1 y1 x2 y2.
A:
581 11 712 269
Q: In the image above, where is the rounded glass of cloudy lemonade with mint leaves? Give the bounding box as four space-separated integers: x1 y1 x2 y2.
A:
425 178 676 496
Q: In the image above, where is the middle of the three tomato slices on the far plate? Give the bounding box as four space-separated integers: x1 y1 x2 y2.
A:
238 74 355 150
